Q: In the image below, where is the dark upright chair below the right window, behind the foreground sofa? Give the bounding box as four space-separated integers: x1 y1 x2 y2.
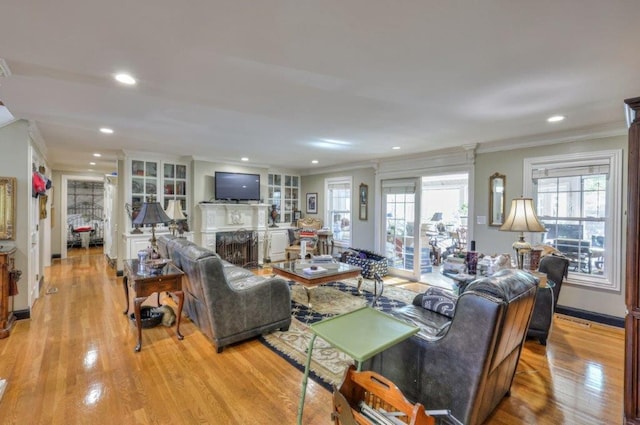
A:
527 255 570 345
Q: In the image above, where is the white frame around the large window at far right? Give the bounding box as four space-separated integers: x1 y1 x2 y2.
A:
523 149 622 291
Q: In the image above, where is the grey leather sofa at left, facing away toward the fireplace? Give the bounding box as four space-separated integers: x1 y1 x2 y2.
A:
158 235 291 353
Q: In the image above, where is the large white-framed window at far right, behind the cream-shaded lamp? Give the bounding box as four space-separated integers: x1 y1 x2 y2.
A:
525 150 622 290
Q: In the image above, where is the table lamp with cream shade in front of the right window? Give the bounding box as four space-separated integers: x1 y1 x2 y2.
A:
500 197 545 269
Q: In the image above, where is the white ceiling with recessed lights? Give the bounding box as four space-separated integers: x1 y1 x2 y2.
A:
0 0 640 173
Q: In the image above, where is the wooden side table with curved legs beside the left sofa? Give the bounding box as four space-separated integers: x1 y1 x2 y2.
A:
122 260 184 352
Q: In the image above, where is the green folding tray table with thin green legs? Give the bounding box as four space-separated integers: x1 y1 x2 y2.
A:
298 307 419 425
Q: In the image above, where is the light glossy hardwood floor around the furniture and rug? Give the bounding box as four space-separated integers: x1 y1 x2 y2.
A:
0 249 624 425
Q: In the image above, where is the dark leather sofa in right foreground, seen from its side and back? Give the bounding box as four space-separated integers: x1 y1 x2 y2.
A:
364 269 538 425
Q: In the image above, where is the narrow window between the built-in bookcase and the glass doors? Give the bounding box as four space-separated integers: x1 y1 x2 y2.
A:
325 177 352 246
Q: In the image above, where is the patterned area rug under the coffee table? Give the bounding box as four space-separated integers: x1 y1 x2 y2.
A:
260 279 416 389
